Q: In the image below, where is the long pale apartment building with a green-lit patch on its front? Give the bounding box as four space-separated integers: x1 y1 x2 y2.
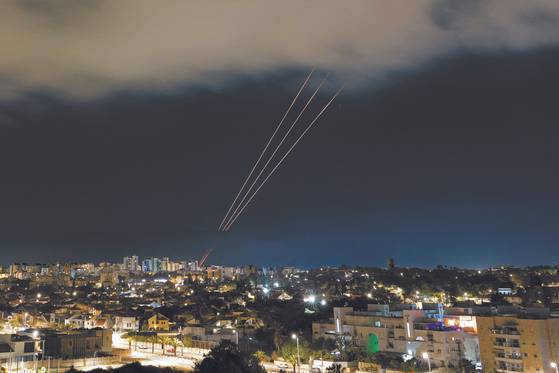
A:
312 305 479 367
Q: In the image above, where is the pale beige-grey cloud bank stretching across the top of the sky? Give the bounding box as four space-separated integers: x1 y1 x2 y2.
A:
0 0 559 98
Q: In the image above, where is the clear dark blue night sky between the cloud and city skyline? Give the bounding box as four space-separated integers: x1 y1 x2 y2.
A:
0 2 559 267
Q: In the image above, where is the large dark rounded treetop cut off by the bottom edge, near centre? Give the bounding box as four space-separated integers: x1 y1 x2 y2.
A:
194 341 266 373
